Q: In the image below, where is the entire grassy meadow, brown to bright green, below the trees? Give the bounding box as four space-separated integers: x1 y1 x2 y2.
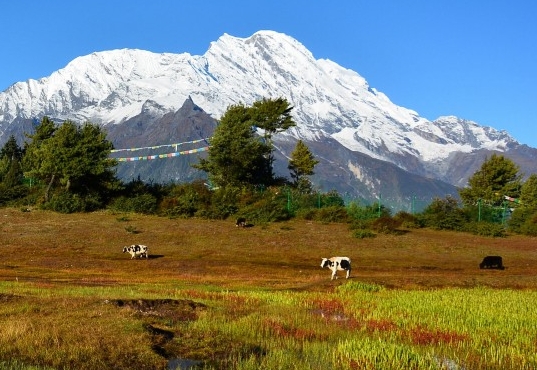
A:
0 208 537 370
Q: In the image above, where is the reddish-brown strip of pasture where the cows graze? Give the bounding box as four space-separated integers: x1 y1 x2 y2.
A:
0 209 537 290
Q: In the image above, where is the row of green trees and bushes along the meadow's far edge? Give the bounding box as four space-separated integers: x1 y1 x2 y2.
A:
0 98 537 237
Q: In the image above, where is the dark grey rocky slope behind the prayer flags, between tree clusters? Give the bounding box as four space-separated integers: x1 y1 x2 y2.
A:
106 99 217 183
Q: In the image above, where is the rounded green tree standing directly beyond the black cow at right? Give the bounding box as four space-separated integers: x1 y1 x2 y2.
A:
459 154 522 206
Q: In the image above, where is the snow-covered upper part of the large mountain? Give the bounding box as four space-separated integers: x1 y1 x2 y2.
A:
0 31 537 205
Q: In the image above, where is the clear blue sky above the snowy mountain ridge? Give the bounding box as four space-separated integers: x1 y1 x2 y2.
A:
0 0 537 148
